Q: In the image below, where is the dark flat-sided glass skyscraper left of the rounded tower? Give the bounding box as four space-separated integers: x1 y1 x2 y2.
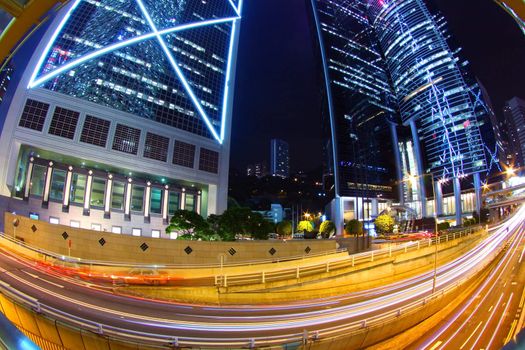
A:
311 0 396 232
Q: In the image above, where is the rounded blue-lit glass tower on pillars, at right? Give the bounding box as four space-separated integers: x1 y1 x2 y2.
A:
369 0 487 223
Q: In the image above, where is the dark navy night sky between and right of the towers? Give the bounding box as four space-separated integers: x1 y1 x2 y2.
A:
231 0 525 175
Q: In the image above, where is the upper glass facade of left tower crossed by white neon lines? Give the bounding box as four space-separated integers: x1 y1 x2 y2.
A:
28 0 242 143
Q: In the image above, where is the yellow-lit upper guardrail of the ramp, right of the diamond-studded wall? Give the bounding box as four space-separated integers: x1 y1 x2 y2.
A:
215 226 484 287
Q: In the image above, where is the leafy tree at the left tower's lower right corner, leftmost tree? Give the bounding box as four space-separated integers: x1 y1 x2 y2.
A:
166 210 211 240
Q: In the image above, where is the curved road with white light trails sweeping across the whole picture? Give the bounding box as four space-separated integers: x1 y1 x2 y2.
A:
0 208 525 348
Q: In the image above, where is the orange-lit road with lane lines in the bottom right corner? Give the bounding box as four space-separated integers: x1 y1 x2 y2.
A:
410 216 525 350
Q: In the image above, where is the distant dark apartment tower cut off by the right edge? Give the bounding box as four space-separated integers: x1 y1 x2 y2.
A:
503 97 525 167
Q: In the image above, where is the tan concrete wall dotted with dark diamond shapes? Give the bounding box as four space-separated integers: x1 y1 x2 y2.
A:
4 212 338 265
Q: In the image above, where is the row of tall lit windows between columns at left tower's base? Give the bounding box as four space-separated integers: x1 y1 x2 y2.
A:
30 164 197 215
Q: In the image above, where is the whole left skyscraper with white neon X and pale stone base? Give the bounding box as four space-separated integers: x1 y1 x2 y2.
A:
0 0 242 236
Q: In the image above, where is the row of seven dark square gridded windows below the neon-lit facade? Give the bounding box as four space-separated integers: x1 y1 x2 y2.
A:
18 99 219 174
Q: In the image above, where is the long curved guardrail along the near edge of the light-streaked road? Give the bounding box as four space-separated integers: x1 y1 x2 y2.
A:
0 223 506 348
